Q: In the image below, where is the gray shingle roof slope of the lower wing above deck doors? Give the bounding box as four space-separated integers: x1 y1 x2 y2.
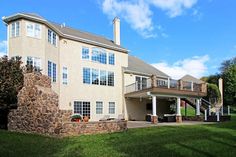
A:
125 55 169 78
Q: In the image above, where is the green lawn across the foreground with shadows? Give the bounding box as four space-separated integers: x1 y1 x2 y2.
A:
0 115 236 157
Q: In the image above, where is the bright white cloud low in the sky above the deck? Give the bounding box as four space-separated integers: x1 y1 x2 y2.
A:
152 55 209 79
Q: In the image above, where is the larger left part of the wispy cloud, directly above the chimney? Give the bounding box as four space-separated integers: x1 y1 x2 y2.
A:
102 0 155 38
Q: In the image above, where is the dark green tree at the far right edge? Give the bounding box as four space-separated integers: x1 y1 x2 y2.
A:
222 64 236 105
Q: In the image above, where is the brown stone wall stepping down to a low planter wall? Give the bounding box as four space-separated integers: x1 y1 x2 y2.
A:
8 73 127 136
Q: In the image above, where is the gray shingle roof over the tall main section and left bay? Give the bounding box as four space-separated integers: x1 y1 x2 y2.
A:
3 13 128 53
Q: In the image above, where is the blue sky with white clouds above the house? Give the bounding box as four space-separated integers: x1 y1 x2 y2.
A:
0 0 236 78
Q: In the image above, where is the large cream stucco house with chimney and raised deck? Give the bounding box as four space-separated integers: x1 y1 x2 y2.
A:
3 13 206 122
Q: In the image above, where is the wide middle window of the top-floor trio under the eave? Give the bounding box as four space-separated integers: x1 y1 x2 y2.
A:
92 48 107 64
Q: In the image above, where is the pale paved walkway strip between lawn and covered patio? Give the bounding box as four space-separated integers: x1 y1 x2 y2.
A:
127 121 216 128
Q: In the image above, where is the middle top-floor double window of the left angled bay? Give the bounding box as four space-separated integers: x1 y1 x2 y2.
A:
26 22 41 38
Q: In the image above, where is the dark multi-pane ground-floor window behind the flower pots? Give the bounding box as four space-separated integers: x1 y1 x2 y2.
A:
74 101 90 118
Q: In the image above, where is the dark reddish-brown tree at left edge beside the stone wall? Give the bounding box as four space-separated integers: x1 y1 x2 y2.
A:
0 56 24 109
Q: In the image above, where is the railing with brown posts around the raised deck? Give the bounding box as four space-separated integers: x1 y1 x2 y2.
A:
125 75 207 93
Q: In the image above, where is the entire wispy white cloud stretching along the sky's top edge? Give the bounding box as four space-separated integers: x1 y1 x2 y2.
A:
102 0 197 38
